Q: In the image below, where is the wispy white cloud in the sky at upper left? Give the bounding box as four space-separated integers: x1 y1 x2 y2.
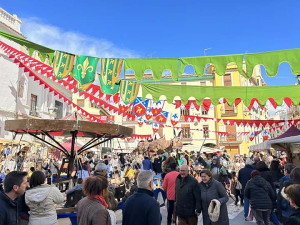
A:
22 18 139 58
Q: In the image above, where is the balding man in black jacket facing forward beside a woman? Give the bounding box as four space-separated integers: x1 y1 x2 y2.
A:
175 165 201 225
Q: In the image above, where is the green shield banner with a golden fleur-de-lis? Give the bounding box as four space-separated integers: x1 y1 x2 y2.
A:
74 55 100 91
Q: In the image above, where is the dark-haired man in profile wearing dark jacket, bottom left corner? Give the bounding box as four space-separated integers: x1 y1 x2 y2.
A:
0 171 28 225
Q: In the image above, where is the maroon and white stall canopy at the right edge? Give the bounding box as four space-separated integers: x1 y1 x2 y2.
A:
250 126 300 152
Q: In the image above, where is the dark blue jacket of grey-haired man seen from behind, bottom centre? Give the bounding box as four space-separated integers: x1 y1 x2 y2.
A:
122 188 161 225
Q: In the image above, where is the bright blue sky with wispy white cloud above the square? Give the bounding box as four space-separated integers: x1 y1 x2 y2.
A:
0 0 300 85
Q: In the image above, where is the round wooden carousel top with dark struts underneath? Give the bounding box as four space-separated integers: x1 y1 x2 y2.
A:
5 119 132 157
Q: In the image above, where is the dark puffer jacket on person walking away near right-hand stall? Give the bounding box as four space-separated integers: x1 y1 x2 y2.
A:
245 175 275 209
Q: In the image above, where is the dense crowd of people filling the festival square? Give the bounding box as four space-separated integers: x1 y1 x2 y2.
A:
0 147 300 225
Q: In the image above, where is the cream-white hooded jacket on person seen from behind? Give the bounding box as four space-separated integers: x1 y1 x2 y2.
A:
25 185 64 225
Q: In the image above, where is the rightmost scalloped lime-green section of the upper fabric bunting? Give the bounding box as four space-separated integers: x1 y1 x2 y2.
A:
245 48 300 78
